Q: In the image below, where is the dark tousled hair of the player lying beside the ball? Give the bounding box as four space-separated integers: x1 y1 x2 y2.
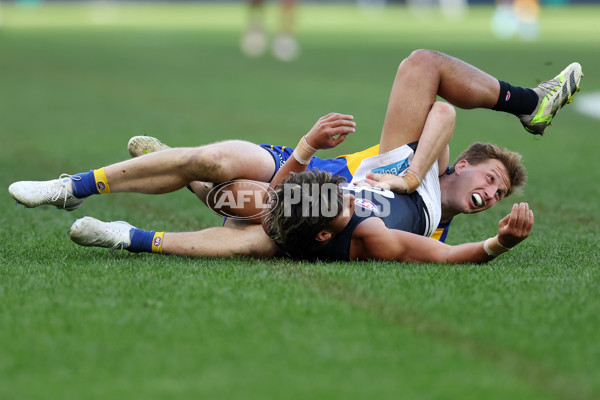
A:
265 169 346 257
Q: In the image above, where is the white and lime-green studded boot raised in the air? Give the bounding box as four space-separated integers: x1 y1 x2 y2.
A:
519 63 583 135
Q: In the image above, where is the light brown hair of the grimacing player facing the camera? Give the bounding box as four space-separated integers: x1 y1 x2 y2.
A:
450 142 527 196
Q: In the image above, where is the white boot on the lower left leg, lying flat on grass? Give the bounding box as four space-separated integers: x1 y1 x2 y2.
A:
68 217 135 251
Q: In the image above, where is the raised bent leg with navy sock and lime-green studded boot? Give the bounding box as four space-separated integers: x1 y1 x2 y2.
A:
380 50 583 152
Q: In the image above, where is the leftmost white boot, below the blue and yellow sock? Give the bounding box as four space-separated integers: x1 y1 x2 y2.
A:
8 174 85 211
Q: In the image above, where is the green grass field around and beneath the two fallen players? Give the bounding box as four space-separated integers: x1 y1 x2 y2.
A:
0 4 600 400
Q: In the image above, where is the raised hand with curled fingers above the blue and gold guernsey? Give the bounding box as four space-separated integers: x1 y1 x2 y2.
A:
306 113 356 150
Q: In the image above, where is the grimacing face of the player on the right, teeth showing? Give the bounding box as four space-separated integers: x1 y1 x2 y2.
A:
455 159 510 214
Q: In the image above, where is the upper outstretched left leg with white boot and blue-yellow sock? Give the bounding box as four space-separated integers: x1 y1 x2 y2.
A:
9 141 275 210
